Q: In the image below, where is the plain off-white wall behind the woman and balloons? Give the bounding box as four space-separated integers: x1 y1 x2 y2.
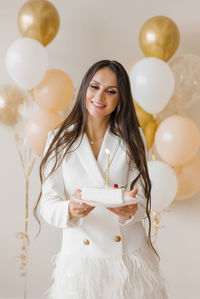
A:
0 0 200 299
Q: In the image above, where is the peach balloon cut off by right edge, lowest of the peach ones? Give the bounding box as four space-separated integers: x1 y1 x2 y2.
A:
174 156 200 199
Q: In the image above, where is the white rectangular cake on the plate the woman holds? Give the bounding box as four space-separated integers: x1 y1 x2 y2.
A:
82 187 124 204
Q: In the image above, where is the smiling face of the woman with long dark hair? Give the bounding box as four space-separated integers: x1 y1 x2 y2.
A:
86 67 119 119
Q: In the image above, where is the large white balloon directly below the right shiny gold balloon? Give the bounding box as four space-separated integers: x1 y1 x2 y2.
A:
130 57 175 113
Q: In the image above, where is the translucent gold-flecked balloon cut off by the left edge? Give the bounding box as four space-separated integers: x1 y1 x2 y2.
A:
0 84 32 129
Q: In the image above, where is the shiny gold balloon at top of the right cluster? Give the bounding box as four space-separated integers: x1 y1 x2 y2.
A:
139 16 180 61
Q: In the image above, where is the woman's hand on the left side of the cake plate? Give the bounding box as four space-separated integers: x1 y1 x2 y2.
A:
69 189 94 218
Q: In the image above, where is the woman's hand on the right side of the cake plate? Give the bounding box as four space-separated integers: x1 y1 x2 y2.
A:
107 188 138 220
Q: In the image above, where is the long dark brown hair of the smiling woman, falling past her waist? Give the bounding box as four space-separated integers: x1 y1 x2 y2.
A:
34 60 156 252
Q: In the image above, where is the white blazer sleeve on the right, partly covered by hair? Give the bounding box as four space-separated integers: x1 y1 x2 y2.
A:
119 128 147 226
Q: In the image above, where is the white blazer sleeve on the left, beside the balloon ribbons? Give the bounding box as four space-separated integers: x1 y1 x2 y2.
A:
39 131 82 229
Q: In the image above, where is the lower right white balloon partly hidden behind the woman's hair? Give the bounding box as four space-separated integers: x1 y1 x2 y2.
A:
148 161 178 212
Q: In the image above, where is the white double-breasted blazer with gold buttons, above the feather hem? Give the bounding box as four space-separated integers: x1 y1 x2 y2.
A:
39 127 148 257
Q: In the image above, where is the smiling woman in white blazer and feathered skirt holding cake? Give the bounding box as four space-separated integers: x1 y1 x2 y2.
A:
35 60 167 299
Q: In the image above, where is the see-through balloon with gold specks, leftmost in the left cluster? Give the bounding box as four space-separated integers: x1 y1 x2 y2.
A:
0 84 26 127
